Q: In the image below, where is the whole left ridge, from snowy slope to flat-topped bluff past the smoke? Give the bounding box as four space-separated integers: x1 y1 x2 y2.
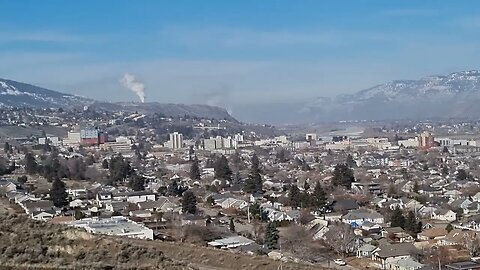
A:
0 79 236 121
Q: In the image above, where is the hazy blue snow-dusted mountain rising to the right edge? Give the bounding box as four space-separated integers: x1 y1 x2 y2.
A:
236 70 480 124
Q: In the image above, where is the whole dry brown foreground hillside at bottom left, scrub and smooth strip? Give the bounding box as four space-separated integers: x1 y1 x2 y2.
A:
0 213 322 270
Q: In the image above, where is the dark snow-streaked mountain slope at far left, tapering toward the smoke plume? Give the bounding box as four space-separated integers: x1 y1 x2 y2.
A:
0 79 93 108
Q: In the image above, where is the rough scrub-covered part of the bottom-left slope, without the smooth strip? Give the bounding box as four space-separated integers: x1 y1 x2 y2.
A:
0 215 191 269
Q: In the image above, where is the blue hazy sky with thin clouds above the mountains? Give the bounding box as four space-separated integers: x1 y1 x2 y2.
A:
0 0 480 113
